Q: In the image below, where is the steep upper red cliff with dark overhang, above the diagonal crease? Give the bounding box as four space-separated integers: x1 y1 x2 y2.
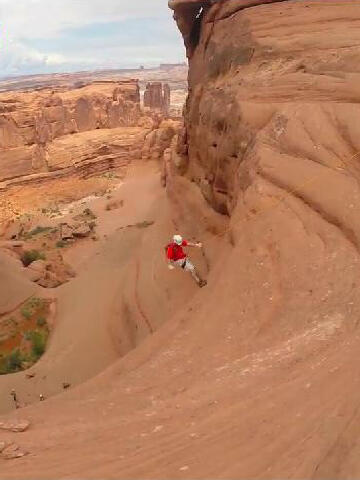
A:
171 0 360 216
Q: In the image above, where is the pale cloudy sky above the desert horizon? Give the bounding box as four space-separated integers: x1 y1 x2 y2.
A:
0 0 184 77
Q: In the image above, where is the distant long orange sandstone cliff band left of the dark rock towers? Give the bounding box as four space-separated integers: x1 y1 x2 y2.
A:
0 80 143 185
